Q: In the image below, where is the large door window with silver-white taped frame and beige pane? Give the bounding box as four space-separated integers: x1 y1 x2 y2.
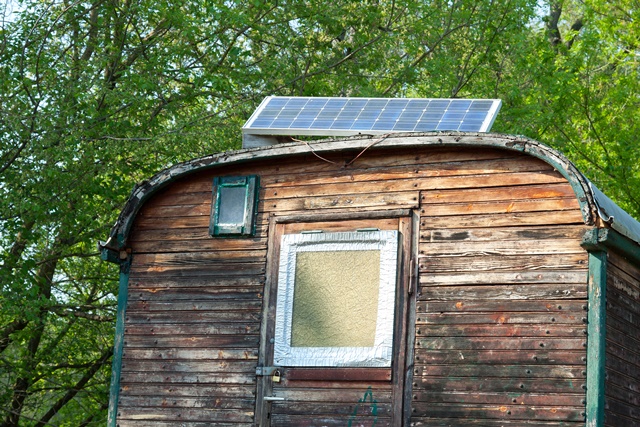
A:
274 230 398 367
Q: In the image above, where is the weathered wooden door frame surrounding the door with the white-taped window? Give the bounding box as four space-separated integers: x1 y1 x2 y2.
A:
254 209 420 426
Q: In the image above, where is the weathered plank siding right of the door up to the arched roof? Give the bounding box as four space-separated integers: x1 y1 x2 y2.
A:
412 150 587 426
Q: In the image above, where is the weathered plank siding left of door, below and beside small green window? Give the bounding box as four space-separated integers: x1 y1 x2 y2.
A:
117 168 266 427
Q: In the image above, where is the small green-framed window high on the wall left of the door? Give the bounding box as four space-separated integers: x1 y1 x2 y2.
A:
209 175 259 236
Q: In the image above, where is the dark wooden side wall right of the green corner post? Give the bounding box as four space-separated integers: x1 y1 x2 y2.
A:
605 253 640 427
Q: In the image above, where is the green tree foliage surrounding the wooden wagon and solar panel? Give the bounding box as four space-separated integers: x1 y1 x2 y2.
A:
0 0 640 426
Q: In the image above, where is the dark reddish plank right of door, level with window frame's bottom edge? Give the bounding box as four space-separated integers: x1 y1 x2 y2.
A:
415 348 587 366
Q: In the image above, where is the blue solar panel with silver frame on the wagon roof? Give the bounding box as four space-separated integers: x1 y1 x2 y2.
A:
242 96 502 147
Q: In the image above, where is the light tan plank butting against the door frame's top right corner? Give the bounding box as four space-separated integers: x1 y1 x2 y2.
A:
420 210 584 230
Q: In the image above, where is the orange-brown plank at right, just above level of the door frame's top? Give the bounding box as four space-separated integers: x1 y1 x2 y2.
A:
420 183 576 205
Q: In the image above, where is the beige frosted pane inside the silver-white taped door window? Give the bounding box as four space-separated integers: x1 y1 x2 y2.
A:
291 251 380 347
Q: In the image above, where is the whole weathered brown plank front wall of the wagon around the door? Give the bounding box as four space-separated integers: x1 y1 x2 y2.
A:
118 148 587 427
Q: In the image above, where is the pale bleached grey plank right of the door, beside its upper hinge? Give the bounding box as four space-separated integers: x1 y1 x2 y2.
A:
420 270 587 288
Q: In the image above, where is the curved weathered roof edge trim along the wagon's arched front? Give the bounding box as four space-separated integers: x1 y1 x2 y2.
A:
99 132 608 254
